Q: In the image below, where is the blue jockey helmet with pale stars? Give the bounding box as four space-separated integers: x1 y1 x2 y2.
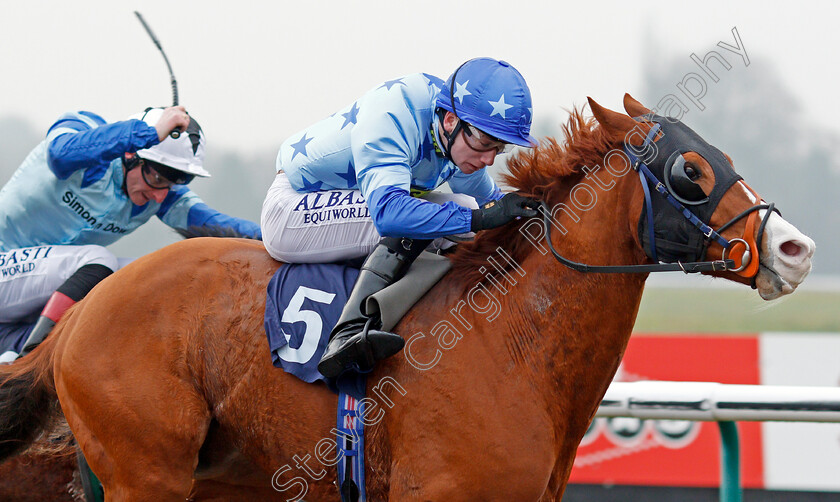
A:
436 58 537 147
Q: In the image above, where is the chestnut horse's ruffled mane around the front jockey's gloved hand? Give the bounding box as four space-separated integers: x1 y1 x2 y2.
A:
448 109 617 284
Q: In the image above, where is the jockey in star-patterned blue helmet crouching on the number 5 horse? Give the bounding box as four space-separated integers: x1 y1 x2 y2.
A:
261 58 537 377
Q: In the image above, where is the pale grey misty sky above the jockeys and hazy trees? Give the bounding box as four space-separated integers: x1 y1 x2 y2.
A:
0 0 840 155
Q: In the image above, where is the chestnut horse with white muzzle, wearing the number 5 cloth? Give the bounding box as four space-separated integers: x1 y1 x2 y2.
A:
0 95 814 502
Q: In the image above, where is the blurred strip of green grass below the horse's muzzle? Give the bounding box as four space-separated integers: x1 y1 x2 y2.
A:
634 287 840 333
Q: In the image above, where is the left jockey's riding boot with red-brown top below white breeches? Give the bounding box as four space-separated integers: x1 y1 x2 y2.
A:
17 263 114 359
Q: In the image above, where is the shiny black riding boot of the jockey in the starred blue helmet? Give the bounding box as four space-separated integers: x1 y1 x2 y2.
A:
318 237 431 378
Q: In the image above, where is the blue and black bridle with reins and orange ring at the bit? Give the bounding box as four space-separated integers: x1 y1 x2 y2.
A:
540 119 781 289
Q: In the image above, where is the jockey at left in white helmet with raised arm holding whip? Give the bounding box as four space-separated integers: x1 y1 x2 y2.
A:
0 106 260 361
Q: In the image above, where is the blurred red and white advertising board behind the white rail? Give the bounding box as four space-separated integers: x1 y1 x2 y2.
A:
570 334 840 491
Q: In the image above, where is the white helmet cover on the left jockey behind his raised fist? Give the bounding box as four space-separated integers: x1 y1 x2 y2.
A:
129 108 210 178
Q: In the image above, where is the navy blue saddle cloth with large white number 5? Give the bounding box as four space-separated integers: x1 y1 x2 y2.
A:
265 263 365 399
